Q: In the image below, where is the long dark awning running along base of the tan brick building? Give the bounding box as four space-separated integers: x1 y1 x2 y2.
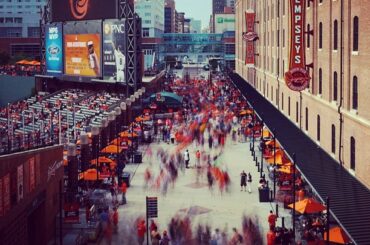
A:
230 74 370 245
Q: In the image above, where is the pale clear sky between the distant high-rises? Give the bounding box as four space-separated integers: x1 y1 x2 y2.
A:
175 0 212 29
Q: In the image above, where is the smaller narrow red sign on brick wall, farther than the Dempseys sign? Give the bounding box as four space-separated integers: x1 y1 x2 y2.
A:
243 10 258 67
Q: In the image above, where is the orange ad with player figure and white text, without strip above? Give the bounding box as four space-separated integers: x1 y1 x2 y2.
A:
64 34 101 77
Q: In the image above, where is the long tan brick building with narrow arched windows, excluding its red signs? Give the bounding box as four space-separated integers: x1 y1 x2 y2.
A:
235 0 370 188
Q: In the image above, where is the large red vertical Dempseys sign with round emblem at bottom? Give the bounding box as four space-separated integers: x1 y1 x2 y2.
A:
285 0 310 91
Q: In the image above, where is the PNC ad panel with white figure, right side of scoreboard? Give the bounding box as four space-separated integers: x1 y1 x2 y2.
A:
103 20 126 82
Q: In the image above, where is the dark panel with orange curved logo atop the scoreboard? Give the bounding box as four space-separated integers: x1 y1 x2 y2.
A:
51 0 118 22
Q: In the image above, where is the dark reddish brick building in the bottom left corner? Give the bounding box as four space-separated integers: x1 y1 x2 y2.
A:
0 146 64 245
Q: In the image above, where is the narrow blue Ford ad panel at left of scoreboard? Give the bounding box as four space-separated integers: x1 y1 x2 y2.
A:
45 23 63 75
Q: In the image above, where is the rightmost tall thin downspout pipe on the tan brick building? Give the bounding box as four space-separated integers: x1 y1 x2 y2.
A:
338 0 344 166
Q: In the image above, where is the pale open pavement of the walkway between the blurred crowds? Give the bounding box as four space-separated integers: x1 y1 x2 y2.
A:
99 138 291 245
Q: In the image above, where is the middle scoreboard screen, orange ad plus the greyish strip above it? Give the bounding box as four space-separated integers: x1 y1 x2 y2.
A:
63 21 102 81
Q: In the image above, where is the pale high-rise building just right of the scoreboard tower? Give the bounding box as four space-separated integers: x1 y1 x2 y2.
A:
135 0 164 37
